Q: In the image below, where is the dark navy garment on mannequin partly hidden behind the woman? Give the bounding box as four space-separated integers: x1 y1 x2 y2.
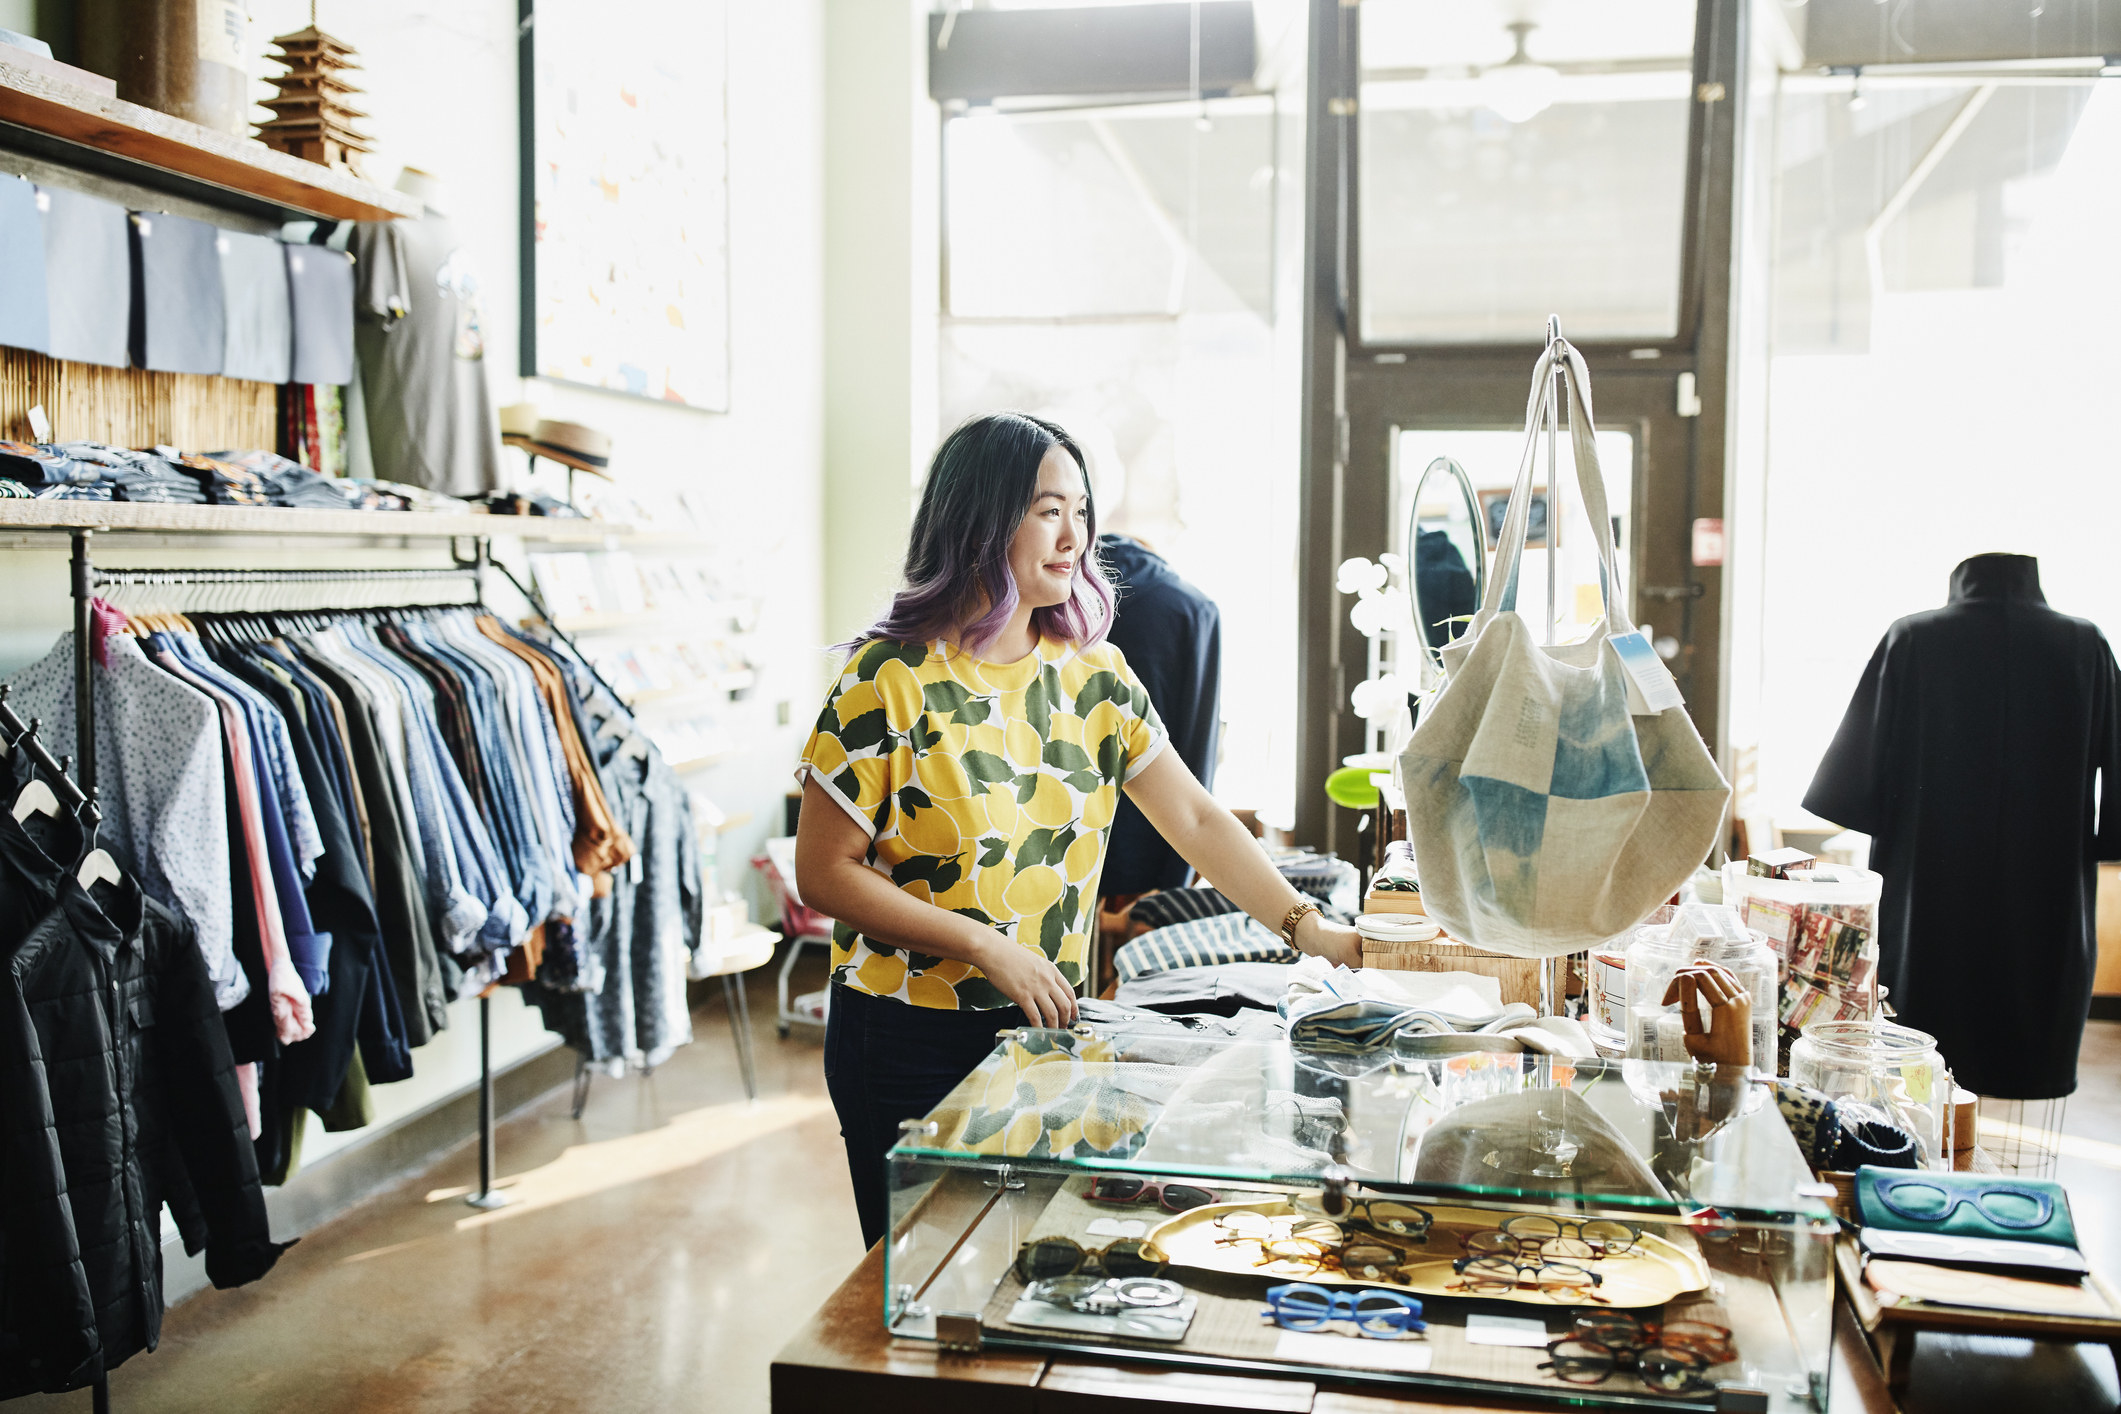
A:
1097 534 1222 899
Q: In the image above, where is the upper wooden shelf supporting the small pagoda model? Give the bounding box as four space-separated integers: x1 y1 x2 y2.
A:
0 59 420 220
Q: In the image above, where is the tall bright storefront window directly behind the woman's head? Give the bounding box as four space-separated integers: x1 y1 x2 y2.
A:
940 93 1302 825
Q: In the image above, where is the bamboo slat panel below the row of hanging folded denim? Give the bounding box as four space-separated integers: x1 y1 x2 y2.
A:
0 348 278 452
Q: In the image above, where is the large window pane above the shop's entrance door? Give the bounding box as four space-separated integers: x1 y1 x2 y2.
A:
1357 0 1695 343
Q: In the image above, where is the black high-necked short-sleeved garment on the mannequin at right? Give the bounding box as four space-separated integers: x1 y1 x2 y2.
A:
1805 555 2121 1100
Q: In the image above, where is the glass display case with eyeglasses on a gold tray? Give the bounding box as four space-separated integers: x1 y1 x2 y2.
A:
884 1013 1837 1410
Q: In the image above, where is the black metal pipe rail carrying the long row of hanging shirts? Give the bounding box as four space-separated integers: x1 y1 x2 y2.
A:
72 530 513 1221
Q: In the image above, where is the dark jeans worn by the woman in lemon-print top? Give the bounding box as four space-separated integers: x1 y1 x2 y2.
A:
825 984 1024 1247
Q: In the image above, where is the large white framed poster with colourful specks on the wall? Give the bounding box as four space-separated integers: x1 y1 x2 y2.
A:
518 0 730 411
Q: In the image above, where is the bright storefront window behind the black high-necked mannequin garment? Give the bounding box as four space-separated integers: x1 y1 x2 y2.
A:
1731 64 2121 829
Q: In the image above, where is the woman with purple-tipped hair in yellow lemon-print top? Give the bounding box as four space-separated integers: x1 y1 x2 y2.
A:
795 413 1362 1244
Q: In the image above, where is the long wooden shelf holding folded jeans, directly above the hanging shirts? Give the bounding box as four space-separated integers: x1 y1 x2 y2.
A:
0 500 630 545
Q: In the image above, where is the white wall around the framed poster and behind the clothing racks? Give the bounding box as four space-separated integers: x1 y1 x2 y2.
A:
0 0 822 1162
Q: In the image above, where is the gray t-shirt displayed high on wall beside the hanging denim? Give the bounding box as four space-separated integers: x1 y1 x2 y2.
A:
352 210 501 496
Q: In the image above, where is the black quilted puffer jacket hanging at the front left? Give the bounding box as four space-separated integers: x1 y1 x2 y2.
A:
0 864 282 1397
